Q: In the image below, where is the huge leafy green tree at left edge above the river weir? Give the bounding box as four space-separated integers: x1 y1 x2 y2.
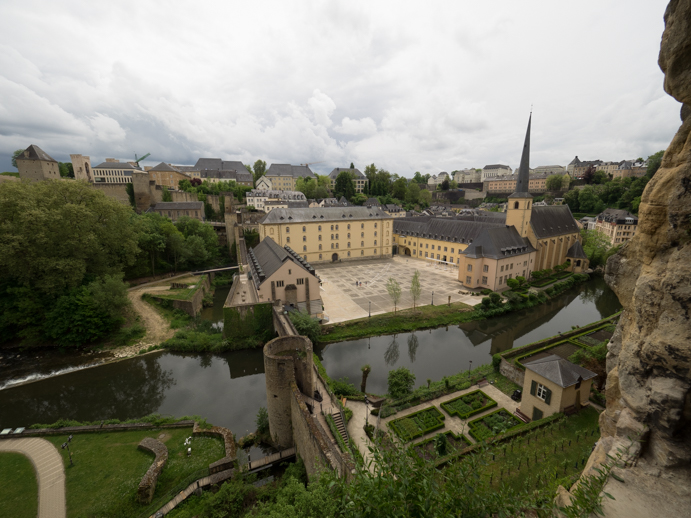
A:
0 182 139 345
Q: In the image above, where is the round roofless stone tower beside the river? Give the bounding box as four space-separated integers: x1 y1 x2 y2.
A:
264 336 314 448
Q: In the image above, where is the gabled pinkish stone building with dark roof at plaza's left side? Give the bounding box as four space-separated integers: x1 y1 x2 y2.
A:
248 237 322 317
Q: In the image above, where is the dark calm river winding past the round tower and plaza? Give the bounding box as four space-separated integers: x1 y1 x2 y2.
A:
0 278 621 436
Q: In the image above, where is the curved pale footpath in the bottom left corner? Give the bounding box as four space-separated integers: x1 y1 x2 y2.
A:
0 438 66 518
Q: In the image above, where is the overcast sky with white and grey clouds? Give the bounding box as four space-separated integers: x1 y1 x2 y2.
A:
0 0 680 176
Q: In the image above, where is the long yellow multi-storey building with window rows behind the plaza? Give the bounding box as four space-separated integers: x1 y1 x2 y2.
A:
259 207 393 263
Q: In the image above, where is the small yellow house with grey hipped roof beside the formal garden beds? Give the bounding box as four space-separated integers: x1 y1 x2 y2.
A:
521 354 597 421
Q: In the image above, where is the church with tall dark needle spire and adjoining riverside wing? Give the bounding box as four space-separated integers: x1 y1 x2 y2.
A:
458 114 588 291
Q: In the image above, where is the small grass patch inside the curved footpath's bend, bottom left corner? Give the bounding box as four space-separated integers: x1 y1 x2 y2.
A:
0 452 38 518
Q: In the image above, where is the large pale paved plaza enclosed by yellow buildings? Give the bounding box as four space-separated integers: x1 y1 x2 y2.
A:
315 256 481 322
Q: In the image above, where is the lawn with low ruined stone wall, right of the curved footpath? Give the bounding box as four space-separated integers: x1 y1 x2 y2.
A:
46 428 225 518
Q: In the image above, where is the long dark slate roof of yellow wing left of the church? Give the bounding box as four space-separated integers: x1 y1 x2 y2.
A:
393 216 505 247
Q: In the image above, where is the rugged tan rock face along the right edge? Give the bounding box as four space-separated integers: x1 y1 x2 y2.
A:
600 0 691 468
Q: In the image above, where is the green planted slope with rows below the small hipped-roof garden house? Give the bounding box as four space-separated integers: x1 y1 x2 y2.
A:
474 408 599 490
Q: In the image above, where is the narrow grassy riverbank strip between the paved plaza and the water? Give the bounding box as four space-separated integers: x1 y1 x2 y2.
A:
320 302 477 343
